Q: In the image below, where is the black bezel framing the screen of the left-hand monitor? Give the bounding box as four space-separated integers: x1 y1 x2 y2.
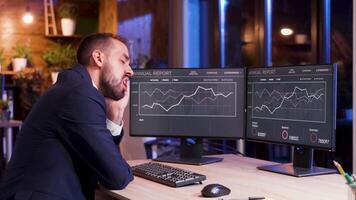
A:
128 66 247 140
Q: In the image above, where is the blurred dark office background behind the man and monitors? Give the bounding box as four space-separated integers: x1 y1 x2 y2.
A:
0 0 356 199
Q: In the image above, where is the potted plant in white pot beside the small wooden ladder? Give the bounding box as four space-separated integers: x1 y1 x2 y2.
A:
58 3 78 36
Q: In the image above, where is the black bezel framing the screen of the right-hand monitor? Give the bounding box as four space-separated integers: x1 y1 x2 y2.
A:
244 63 337 152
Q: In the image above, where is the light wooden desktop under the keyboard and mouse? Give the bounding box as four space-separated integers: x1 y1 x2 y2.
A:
102 155 348 200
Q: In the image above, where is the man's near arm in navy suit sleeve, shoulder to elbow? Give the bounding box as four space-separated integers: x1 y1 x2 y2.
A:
59 88 133 189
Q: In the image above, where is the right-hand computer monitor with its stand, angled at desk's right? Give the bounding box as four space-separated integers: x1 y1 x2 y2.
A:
246 65 337 177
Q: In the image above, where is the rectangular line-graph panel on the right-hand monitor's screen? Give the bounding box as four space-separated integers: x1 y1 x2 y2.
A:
251 82 326 122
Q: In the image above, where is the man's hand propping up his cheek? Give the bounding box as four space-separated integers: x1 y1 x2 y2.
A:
105 80 130 125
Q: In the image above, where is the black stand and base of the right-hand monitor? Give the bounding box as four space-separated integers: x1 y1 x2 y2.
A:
257 147 336 177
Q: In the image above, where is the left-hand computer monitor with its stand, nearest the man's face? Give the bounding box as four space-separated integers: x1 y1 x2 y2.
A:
130 68 246 165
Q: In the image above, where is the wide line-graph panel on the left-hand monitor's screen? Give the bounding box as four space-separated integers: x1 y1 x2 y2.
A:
139 82 236 117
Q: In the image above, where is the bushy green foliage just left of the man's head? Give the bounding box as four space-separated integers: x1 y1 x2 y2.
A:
43 44 76 71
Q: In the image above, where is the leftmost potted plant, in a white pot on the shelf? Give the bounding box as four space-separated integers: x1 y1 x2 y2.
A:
12 44 32 71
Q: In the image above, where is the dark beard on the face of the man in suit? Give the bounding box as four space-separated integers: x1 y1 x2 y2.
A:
100 63 125 101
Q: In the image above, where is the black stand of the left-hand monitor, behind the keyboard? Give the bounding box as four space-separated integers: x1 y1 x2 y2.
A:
154 138 223 165
